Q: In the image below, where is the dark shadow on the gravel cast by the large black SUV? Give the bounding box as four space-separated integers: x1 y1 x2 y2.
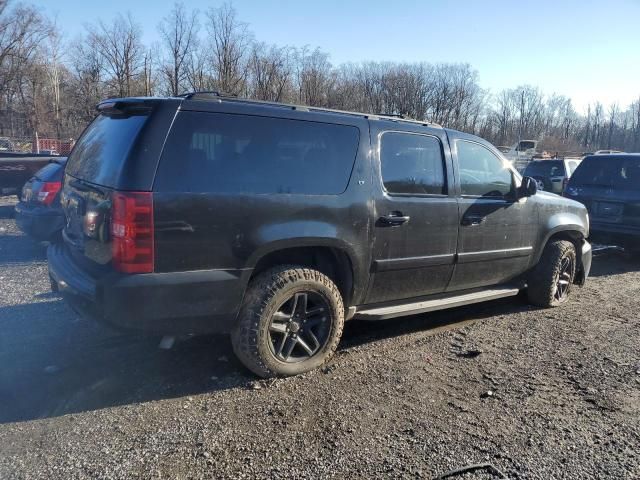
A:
0 294 529 423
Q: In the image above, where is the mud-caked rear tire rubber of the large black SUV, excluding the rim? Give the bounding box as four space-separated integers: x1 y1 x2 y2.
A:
231 265 344 378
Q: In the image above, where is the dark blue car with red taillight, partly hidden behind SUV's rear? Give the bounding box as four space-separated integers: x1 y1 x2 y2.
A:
15 157 67 241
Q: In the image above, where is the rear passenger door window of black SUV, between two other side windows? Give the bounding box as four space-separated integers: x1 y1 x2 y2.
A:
380 132 447 194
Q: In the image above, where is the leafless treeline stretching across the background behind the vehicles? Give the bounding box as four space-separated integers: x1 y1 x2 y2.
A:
0 0 640 152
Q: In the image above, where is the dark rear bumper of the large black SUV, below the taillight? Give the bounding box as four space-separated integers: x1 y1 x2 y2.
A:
47 244 248 334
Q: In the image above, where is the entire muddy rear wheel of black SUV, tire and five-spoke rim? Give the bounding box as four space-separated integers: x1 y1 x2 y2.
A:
231 265 344 377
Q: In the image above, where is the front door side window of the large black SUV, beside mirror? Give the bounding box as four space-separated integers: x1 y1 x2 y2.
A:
456 140 513 197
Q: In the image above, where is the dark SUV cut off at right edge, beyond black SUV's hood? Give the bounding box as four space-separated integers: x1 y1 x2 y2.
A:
565 153 640 251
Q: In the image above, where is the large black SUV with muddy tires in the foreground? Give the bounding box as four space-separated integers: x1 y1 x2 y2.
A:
48 94 591 376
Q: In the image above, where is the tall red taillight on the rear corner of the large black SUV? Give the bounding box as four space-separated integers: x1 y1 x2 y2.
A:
111 192 153 273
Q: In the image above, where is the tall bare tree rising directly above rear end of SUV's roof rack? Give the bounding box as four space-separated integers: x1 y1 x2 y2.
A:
158 3 199 95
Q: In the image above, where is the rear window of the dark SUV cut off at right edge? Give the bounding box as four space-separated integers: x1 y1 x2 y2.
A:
571 156 640 190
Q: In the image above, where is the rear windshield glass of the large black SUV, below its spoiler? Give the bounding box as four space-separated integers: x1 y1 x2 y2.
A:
66 114 147 187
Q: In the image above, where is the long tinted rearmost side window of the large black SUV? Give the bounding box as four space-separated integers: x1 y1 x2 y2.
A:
155 112 359 194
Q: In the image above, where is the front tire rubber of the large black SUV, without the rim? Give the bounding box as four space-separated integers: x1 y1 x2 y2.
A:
527 240 577 308
